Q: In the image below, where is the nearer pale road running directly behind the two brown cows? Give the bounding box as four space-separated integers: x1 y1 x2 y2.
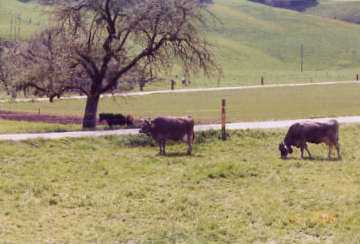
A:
0 116 360 140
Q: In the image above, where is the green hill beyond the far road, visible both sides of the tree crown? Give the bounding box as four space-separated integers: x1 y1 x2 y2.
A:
0 0 360 88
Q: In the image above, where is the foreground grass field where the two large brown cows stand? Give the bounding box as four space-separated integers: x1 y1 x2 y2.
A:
0 126 360 243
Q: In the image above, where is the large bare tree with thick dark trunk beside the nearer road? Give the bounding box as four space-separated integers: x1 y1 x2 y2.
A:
11 0 219 129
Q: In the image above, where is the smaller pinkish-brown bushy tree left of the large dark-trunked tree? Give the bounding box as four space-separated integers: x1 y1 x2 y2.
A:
6 28 89 102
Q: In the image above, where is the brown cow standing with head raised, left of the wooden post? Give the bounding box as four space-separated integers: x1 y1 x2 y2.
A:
139 117 195 155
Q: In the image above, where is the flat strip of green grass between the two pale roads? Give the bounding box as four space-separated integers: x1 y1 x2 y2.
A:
0 84 360 129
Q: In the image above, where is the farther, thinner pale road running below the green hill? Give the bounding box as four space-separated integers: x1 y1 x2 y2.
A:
0 81 360 103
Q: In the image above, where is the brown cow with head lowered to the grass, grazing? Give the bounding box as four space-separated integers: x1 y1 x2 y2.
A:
279 120 341 159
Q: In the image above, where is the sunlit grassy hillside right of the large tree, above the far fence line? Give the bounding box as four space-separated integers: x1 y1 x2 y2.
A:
202 0 360 86
